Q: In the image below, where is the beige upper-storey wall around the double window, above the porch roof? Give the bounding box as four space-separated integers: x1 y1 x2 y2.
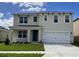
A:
14 14 39 26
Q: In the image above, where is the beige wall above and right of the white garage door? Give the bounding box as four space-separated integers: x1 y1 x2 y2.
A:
39 13 73 43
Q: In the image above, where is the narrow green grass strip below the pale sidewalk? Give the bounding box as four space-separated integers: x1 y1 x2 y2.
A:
0 53 44 57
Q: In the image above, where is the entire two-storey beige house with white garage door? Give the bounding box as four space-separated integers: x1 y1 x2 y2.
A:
10 12 73 43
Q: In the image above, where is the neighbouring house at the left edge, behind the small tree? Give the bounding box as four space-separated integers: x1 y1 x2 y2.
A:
0 26 9 42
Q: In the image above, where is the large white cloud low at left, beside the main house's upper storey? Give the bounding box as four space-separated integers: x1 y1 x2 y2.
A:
0 17 13 28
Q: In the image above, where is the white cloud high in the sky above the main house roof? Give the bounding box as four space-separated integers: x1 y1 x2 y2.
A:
12 2 46 12
